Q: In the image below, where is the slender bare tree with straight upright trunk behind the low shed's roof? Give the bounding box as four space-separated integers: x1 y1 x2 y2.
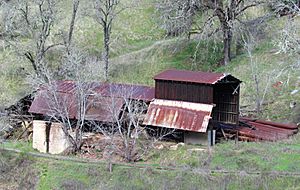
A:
94 0 125 81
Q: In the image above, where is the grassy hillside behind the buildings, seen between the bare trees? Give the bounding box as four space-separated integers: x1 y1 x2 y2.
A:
0 0 300 122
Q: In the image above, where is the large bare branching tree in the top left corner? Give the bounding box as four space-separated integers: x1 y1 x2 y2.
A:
4 0 59 80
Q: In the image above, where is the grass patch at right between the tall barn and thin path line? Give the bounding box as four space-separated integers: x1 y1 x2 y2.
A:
144 135 300 172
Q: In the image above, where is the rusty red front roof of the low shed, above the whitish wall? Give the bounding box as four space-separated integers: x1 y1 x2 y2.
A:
29 90 125 122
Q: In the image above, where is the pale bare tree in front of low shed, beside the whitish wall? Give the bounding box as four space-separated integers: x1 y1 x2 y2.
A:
28 45 100 152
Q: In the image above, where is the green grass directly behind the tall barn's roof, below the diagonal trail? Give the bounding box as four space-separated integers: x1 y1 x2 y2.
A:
112 39 221 86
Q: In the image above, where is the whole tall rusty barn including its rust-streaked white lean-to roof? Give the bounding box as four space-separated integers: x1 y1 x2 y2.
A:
144 70 241 144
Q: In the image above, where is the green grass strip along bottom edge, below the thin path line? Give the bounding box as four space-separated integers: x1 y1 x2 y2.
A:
1 149 300 189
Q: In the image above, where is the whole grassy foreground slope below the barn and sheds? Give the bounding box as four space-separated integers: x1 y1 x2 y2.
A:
0 139 300 189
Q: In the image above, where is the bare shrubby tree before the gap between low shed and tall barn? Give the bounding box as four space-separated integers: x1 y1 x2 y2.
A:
90 84 175 164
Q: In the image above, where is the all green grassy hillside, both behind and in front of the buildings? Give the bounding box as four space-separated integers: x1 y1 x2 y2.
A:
0 0 300 189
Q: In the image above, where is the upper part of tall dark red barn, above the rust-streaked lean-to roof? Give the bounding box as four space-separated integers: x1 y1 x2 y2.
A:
154 70 241 125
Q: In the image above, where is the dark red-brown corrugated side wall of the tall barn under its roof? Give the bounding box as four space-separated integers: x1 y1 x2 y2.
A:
155 80 213 104
